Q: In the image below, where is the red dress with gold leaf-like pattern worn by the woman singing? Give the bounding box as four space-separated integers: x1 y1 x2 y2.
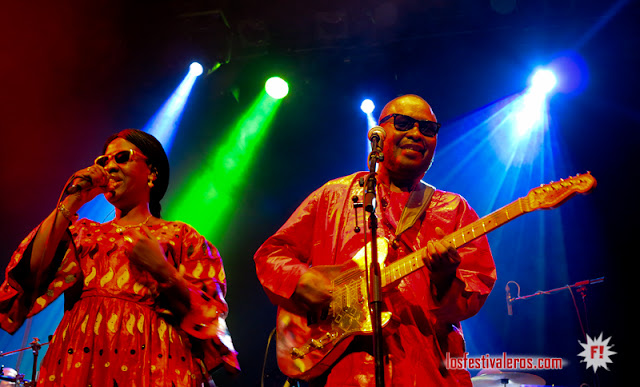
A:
0 219 239 387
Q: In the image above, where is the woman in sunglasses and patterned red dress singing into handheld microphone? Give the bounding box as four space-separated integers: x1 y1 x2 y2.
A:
0 129 239 387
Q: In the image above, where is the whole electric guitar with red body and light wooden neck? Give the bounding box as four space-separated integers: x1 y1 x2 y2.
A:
276 173 596 380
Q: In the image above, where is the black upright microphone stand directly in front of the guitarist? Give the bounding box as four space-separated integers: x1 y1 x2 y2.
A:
363 139 384 387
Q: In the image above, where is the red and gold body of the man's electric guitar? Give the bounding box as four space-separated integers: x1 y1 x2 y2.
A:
276 244 391 380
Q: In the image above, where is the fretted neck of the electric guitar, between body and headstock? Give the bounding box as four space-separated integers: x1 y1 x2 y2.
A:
381 198 531 287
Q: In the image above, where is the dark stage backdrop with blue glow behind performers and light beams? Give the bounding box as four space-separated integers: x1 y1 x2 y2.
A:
0 0 640 386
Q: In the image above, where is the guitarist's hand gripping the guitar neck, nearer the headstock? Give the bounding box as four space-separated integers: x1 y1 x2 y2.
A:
423 227 461 299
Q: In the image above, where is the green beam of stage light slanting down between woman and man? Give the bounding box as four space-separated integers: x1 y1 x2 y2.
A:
167 91 281 247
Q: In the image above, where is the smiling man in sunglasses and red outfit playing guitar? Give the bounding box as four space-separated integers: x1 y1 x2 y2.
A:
254 95 496 386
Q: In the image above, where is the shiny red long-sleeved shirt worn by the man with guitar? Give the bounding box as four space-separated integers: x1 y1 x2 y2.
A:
254 173 496 386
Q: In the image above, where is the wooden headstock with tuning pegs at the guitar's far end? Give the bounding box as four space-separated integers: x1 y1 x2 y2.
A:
527 172 596 210
